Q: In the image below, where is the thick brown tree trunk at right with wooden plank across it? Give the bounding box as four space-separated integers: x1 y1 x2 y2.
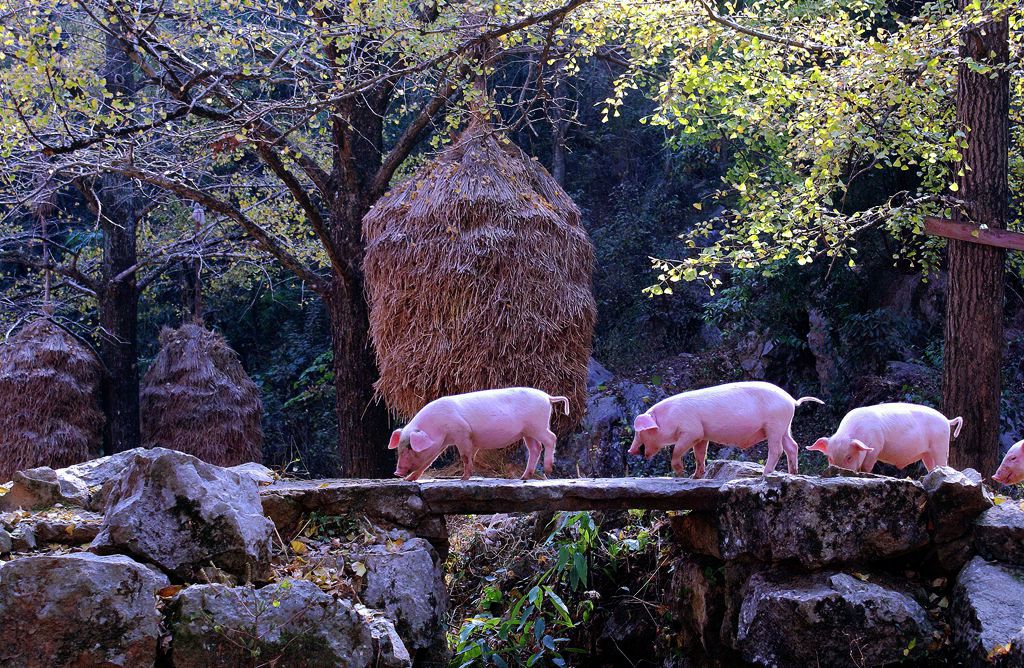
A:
942 0 1010 476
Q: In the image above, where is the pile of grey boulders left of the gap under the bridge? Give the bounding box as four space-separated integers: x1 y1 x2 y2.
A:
0 448 428 668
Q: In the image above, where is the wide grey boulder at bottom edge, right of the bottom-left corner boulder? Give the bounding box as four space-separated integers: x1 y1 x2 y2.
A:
168 580 412 668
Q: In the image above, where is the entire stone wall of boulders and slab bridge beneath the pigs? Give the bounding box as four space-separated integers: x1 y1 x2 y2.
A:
0 449 1024 666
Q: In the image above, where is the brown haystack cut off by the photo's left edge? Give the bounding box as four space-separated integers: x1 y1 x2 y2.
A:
0 318 103 481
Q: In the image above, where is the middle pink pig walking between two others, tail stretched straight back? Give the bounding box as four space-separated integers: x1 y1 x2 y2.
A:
630 382 824 477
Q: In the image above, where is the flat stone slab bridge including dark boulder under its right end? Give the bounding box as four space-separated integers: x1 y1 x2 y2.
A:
261 462 974 568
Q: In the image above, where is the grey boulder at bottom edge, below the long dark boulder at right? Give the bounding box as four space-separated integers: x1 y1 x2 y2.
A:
736 573 934 666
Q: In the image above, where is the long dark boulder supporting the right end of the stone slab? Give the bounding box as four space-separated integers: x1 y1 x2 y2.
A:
674 473 929 568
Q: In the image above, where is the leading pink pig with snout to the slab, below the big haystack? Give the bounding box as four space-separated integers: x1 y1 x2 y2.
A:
388 387 569 481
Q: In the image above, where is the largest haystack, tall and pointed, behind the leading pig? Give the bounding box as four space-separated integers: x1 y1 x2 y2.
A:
362 118 596 433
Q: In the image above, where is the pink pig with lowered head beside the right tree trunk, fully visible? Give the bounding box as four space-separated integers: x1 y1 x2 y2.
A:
808 404 964 472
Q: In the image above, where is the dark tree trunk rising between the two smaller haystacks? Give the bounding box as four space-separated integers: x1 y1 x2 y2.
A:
96 31 139 454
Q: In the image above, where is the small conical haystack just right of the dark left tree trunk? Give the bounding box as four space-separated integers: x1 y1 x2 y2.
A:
140 324 263 466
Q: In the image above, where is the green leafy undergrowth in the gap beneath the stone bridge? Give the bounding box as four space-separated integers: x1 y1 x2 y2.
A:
446 510 672 668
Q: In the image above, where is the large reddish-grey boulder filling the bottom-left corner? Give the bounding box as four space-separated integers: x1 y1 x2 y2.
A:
0 552 169 668
